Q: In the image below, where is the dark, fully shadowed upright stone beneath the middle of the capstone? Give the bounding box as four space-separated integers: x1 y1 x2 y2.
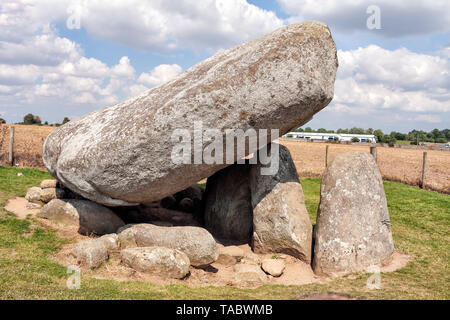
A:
204 164 253 241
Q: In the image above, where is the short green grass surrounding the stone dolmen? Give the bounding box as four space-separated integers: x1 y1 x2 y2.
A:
0 167 450 299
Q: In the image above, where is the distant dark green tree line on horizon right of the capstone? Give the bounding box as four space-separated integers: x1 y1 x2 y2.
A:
294 127 450 144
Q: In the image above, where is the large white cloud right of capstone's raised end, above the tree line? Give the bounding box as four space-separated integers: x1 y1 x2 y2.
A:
330 45 450 118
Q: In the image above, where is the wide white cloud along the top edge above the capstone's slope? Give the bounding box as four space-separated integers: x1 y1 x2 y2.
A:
21 0 283 51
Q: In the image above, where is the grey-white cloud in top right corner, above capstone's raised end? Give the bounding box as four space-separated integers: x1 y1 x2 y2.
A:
277 0 450 37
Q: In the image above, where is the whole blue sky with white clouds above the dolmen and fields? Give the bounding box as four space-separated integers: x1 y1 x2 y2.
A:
0 0 450 132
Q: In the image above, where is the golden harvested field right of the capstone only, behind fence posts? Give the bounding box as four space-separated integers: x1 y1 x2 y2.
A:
279 139 450 194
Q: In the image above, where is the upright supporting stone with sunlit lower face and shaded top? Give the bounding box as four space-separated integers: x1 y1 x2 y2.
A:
250 144 312 263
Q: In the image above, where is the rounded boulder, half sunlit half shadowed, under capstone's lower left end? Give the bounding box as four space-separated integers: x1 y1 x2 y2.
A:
38 199 124 235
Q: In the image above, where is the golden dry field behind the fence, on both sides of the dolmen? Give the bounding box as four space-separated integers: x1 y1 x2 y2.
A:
0 125 450 194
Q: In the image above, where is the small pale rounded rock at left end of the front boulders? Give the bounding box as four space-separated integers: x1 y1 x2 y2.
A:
72 239 109 269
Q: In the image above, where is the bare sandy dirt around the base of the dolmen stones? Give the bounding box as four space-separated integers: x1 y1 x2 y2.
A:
5 197 411 288
